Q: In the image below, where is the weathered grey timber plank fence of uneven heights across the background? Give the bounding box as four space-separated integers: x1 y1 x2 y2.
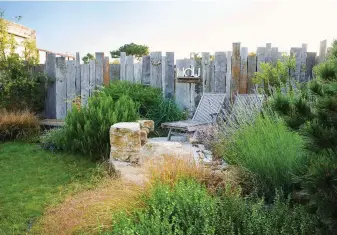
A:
37 40 327 119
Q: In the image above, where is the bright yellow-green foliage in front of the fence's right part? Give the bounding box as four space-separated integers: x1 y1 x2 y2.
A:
253 55 296 95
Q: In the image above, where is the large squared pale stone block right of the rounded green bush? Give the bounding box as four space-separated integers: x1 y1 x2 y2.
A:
110 122 141 162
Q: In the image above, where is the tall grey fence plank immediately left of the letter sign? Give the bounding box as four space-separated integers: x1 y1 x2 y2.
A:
164 52 174 99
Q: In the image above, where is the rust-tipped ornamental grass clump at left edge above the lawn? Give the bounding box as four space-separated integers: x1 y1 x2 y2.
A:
0 110 40 141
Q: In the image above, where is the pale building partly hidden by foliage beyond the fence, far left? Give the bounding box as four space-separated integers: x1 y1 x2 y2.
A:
7 21 75 64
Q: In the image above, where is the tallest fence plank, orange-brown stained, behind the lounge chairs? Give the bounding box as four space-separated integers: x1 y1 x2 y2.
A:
231 43 241 95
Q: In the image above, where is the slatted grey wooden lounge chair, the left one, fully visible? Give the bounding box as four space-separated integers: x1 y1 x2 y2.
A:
161 93 228 140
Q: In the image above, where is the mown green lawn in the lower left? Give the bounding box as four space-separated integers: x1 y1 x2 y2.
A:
0 142 102 235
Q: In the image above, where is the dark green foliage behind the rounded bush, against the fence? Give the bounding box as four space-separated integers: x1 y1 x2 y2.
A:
101 81 186 129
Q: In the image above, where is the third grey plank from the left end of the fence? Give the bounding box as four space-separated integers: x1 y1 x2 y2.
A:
66 60 77 112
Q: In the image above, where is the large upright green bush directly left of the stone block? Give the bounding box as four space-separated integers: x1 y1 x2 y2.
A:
49 92 138 159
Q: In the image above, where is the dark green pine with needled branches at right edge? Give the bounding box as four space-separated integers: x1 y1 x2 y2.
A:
270 41 337 232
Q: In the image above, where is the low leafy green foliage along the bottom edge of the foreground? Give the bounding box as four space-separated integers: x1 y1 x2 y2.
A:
109 180 316 235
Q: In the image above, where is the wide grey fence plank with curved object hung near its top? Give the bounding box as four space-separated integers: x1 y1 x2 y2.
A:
150 51 162 89
